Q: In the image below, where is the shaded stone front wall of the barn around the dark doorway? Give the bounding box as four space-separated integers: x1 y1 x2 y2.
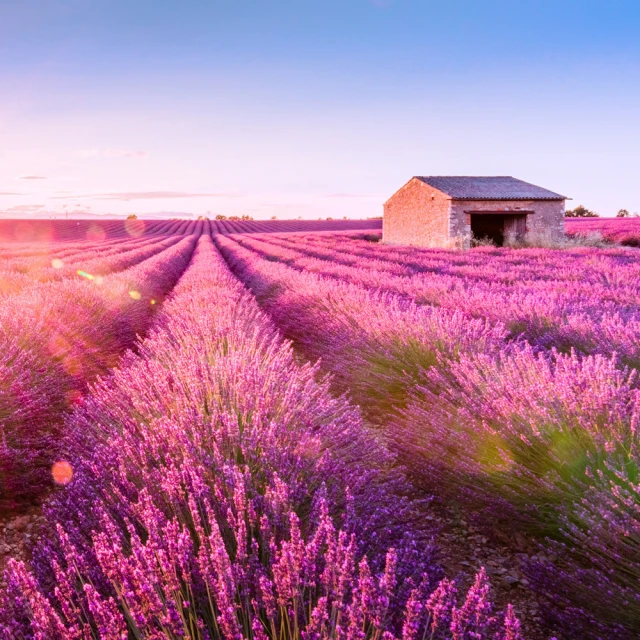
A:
449 200 565 248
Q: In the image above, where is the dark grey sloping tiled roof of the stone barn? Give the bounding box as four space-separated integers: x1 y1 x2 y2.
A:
416 176 566 200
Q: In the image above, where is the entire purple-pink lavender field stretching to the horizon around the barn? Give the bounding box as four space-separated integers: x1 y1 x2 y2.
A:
0 220 640 640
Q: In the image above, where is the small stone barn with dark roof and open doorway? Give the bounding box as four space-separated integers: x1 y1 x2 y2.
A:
382 176 567 248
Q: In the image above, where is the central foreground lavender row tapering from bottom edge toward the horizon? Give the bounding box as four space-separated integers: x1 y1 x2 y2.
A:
2 237 522 640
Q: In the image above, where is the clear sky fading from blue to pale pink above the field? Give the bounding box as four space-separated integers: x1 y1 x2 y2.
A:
0 0 640 219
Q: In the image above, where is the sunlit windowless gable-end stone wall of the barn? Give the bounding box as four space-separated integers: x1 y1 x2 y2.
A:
382 178 451 247
